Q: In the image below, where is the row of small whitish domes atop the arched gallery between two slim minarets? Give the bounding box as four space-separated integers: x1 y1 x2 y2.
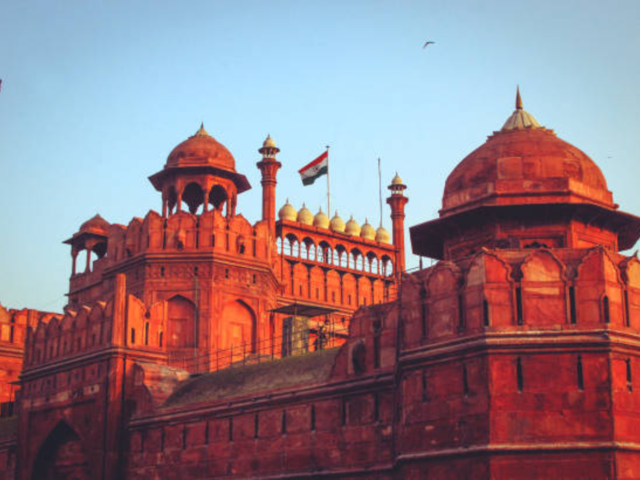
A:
278 200 391 243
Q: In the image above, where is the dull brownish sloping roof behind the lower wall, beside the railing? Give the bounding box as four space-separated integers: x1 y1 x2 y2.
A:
164 347 340 407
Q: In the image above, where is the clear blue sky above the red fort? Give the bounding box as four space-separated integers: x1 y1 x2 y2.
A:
0 0 640 310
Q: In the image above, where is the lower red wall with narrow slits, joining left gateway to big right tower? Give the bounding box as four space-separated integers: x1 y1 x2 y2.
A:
128 305 397 478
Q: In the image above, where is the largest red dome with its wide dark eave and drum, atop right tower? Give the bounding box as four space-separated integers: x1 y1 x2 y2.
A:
410 92 640 259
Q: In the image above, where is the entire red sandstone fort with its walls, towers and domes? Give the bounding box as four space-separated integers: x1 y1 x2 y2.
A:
0 95 640 479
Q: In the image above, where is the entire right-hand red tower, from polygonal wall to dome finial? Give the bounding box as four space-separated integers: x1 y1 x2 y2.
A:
394 92 640 479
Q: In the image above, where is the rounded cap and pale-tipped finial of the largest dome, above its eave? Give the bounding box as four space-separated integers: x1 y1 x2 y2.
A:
441 95 613 215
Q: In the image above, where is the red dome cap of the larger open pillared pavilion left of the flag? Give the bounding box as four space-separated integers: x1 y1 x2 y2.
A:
166 125 236 172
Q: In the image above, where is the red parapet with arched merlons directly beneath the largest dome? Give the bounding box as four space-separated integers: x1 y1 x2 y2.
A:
400 247 640 348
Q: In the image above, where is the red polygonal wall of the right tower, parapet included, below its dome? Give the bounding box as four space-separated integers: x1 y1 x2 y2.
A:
400 248 639 478
